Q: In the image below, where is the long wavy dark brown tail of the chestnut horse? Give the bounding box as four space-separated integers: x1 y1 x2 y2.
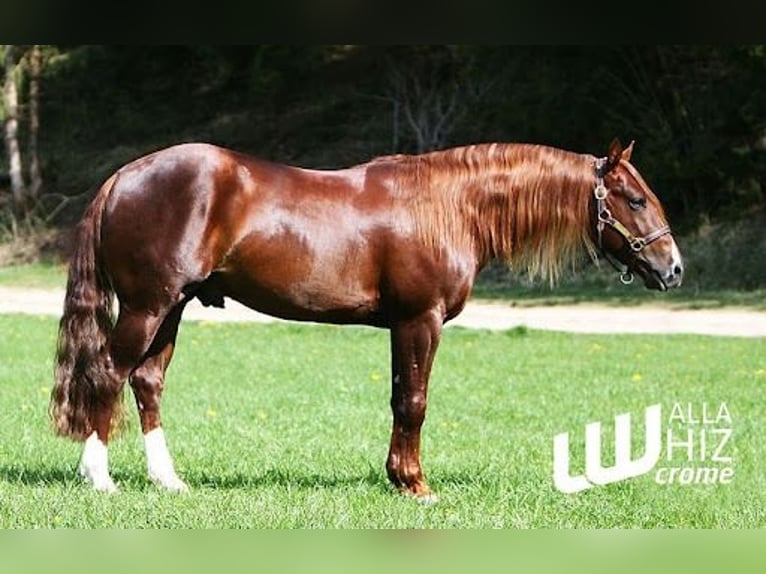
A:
48 173 122 440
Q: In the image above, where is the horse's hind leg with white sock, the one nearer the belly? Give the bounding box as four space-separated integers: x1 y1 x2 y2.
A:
130 302 189 492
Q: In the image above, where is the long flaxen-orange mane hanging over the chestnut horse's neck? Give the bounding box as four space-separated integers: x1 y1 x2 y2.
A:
388 143 595 282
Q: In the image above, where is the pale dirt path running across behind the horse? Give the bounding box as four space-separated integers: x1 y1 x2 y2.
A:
0 287 766 337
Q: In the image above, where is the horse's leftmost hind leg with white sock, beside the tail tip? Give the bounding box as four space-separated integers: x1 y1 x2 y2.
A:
80 309 163 492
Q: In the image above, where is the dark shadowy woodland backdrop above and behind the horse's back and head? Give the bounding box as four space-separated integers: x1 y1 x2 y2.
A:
0 45 766 289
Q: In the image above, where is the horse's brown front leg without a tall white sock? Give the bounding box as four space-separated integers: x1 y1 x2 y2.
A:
386 310 442 502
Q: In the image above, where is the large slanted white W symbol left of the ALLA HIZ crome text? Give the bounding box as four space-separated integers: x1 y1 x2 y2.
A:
553 405 662 494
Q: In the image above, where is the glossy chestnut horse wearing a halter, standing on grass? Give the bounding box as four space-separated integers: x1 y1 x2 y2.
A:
50 140 683 498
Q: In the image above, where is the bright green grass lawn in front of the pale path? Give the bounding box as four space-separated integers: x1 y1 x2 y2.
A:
0 315 766 528
